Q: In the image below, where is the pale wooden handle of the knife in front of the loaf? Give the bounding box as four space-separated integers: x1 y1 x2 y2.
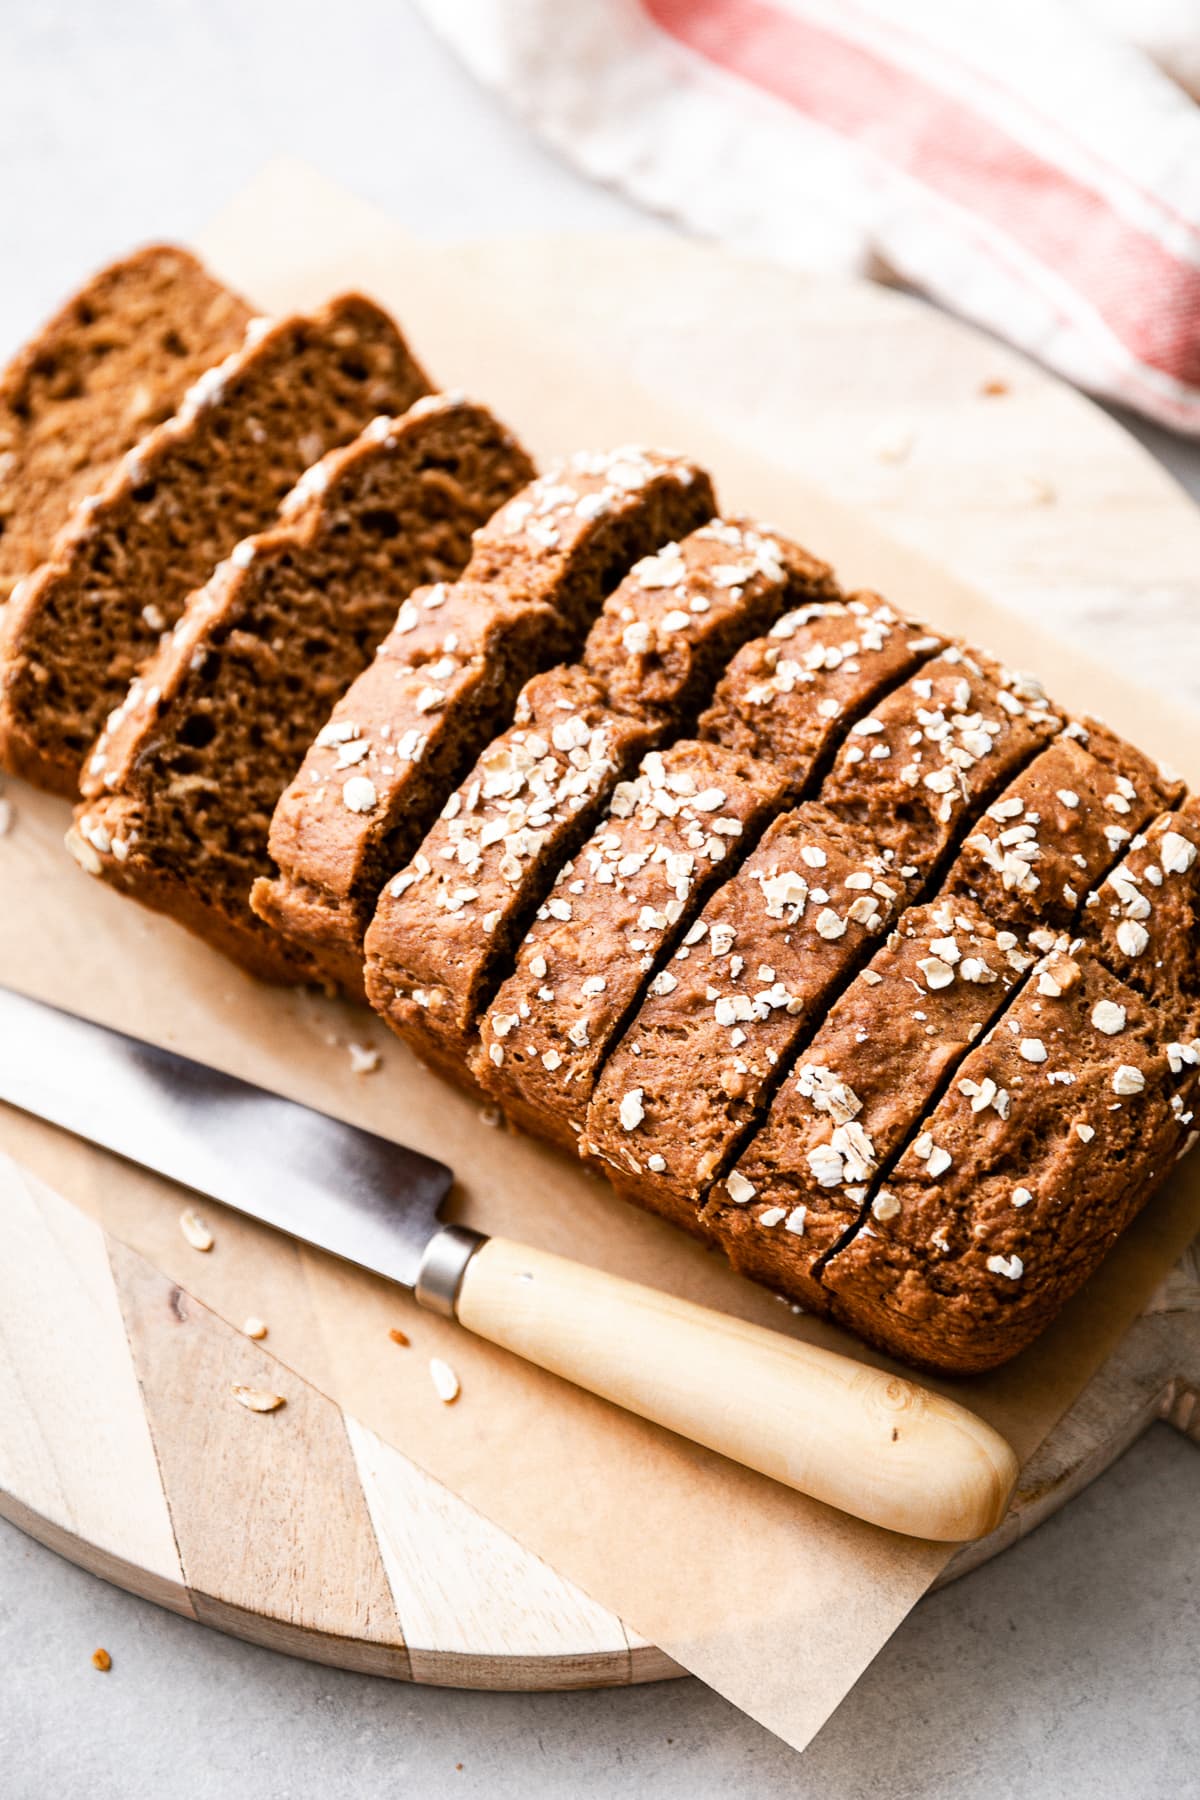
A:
455 1238 1018 1543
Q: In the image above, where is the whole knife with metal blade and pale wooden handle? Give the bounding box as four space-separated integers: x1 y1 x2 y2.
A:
0 986 1018 1543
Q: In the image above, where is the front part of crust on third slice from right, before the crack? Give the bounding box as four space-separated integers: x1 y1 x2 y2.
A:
583 801 896 1229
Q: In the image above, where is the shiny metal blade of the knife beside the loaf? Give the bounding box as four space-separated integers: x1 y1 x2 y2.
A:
0 986 453 1287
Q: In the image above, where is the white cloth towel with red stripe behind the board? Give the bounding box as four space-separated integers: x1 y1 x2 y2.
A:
413 0 1200 436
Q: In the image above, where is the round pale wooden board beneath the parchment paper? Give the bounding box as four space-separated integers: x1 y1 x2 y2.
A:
0 221 1200 1688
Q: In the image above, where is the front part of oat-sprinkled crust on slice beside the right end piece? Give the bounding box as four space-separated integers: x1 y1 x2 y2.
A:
703 896 1034 1310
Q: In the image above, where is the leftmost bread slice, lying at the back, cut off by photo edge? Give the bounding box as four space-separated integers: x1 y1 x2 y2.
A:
0 243 250 607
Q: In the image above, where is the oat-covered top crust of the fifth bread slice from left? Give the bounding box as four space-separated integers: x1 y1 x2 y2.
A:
367 520 829 1064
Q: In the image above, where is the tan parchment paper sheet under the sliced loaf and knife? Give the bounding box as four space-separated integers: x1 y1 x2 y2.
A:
0 166 1200 1748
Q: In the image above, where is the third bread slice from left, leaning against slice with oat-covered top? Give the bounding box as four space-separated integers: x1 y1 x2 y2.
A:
70 396 531 981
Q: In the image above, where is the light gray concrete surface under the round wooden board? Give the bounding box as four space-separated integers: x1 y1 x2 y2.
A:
0 0 1200 1800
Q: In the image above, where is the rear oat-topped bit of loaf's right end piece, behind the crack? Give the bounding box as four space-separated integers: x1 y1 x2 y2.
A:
1083 797 1200 1037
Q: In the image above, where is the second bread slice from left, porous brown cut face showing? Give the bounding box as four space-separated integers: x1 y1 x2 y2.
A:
0 293 428 794
